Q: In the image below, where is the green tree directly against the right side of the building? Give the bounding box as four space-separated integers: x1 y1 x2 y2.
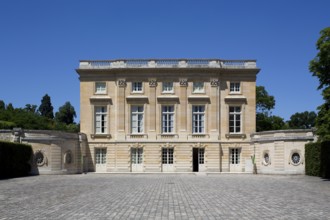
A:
256 86 286 131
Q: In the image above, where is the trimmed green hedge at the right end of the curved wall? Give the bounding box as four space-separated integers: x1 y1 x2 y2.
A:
305 141 330 178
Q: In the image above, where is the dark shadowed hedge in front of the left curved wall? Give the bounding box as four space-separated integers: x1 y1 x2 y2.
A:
0 141 33 179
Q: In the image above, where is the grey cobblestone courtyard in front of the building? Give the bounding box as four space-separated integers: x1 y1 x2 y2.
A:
0 174 330 220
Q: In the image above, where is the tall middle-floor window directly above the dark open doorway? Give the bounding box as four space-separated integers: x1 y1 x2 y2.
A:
192 105 205 134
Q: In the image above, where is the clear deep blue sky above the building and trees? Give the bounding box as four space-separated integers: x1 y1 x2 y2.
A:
0 0 330 121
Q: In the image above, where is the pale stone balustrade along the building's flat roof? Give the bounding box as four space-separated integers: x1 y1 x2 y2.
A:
79 59 257 69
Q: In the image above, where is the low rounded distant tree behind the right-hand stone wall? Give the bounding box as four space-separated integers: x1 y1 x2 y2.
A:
288 111 316 129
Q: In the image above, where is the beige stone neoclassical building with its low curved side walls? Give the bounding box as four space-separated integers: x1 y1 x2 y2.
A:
0 59 315 174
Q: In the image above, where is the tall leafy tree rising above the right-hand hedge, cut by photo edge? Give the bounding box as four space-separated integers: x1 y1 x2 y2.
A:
309 27 330 141
